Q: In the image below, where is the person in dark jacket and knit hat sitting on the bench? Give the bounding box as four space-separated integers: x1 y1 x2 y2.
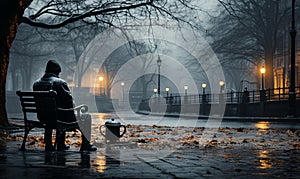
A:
33 60 97 151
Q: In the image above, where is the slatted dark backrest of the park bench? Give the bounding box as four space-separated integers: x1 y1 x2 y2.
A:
16 90 58 125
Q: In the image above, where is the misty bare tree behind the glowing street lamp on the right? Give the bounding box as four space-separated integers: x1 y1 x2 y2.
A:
215 0 290 88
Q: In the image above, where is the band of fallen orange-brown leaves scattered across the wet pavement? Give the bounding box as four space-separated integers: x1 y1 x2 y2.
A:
1 125 300 152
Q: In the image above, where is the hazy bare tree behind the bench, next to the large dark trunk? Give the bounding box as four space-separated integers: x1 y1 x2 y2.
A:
10 24 54 91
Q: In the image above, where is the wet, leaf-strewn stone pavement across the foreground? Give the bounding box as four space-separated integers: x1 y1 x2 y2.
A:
0 112 300 178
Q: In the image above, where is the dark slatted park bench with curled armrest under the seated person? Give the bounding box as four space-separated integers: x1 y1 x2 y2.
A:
16 90 88 151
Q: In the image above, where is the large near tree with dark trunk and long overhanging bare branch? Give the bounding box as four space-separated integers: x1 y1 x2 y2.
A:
0 0 204 125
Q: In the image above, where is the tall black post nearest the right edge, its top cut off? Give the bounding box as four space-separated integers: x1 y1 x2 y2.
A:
288 0 297 116
